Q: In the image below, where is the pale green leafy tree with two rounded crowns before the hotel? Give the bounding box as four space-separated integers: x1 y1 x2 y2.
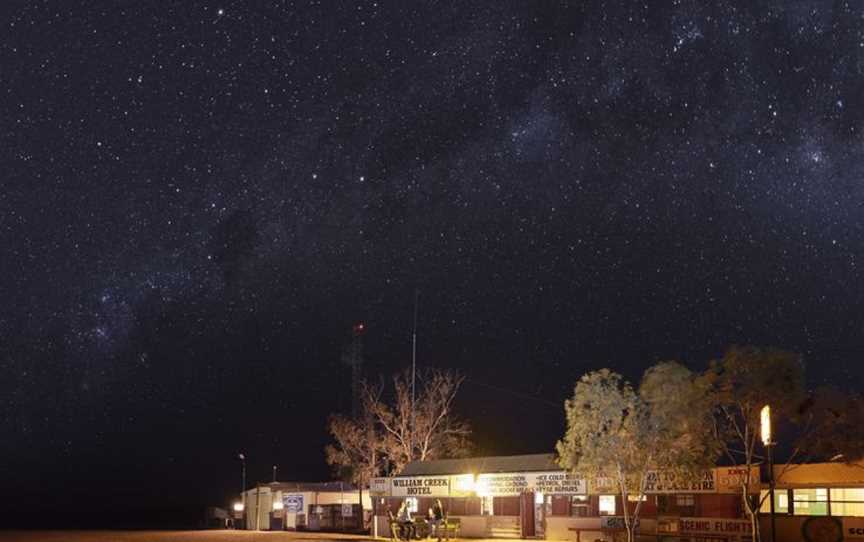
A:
557 362 716 542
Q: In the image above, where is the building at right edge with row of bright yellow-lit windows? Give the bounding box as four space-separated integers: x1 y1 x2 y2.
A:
760 462 864 542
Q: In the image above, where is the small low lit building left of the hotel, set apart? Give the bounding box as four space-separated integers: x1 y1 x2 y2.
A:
241 482 372 532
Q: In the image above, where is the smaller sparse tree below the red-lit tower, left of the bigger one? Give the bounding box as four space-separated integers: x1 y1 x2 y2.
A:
324 383 386 507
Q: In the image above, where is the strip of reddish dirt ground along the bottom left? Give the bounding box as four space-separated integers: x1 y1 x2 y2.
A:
0 531 373 542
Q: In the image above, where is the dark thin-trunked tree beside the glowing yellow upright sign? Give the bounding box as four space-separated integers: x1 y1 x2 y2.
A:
706 346 806 540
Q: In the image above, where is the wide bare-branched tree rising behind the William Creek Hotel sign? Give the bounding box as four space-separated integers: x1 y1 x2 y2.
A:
371 369 471 472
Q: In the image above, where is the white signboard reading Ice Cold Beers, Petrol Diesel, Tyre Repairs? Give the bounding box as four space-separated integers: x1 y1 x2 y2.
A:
475 471 587 497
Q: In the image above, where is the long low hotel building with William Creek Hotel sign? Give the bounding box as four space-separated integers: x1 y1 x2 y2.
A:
370 454 760 542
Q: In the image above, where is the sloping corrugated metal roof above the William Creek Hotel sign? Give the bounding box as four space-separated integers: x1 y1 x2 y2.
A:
397 454 561 476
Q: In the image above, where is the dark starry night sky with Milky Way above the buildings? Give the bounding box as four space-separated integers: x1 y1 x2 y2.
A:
0 0 864 525
